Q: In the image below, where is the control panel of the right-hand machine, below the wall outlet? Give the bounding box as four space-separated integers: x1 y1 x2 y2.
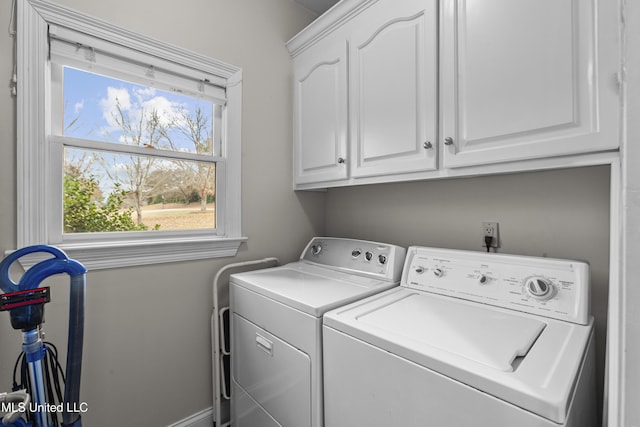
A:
401 246 590 324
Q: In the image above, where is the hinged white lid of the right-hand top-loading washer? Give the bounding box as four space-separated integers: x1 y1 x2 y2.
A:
358 293 545 372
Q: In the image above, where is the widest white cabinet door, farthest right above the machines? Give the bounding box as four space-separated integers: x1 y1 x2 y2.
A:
440 0 619 167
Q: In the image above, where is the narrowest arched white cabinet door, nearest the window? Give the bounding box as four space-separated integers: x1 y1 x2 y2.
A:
293 37 348 184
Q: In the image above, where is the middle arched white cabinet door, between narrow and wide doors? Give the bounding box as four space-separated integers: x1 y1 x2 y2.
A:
349 0 438 178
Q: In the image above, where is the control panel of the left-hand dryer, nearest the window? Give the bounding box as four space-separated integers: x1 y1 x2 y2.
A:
300 237 406 282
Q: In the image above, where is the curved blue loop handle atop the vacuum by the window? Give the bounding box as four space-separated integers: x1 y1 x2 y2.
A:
0 245 87 293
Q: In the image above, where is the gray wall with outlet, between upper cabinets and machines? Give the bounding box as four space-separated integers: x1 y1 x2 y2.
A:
325 166 610 414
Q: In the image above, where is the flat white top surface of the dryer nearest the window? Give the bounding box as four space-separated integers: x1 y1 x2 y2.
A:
230 262 399 317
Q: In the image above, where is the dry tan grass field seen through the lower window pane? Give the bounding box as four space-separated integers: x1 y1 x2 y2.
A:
133 203 215 231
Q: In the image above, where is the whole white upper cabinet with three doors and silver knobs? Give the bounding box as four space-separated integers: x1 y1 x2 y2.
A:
287 0 621 189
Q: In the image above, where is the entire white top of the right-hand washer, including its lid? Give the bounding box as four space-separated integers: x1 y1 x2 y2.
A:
323 287 593 423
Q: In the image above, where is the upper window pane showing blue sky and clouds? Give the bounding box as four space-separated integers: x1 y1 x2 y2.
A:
62 67 216 155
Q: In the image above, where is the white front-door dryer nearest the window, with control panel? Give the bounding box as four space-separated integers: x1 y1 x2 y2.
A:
229 237 406 427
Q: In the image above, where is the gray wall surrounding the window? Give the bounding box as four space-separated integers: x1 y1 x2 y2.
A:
0 0 324 427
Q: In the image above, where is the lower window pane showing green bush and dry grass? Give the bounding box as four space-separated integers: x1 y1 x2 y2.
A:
63 147 216 233
